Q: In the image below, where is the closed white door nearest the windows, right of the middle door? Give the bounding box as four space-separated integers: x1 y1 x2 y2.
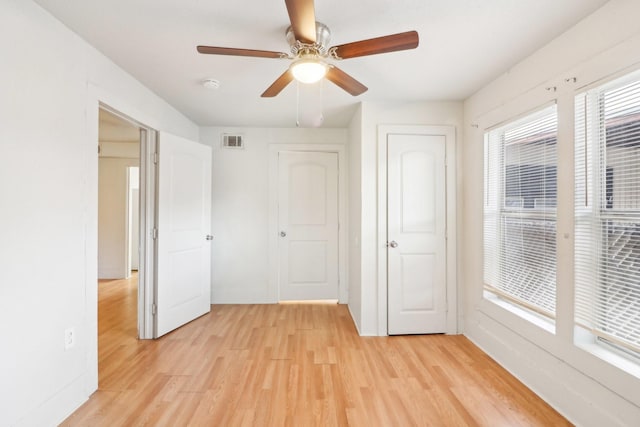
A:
387 134 447 335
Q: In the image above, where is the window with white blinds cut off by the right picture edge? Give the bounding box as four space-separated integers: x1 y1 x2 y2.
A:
575 74 640 355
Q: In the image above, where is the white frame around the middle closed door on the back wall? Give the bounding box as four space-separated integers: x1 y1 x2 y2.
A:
267 144 349 304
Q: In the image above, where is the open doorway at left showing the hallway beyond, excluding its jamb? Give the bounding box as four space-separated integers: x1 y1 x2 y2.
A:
98 108 140 385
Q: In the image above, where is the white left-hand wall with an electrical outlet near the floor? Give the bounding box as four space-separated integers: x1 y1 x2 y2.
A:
0 0 198 426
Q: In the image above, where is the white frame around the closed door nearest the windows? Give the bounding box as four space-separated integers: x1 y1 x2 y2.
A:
377 125 458 336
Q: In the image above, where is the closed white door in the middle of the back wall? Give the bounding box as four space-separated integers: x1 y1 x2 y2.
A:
278 152 339 301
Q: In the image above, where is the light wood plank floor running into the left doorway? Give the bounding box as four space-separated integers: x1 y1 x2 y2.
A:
63 280 570 427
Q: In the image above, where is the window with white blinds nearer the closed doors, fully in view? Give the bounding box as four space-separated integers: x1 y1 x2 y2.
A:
484 104 557 318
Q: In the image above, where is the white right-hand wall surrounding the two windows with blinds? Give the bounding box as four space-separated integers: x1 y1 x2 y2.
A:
459 0 640 426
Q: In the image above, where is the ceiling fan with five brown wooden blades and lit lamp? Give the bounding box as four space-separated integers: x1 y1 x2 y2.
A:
197 0 418 98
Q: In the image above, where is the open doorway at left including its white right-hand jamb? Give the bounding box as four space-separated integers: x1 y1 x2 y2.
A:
97 104 155 360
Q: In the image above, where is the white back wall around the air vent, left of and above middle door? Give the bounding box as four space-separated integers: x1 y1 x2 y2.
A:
200 128 347 304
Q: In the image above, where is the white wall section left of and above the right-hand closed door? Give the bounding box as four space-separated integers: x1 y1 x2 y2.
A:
349 102 463 335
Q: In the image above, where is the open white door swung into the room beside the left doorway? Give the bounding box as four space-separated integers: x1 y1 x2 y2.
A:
156 132 211 337
